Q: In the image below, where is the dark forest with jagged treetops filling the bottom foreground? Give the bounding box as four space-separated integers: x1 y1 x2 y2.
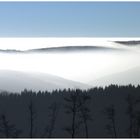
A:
0 85 140 138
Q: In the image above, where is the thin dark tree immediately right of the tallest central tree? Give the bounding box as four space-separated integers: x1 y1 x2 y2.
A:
79 93 92 138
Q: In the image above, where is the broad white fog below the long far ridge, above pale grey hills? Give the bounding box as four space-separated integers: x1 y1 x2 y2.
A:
0 48 140 83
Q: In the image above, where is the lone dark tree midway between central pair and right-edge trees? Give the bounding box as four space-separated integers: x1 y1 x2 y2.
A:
105 105 117 138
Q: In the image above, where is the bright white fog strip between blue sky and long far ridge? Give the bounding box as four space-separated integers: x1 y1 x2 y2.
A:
0 37 140 50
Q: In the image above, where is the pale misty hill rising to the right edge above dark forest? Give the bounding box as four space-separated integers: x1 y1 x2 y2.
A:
89 67 140 86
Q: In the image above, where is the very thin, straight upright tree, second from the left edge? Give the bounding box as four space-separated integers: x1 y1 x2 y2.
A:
28 100 36 138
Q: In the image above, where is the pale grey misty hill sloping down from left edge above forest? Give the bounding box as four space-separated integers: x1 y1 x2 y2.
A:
0 70 90 92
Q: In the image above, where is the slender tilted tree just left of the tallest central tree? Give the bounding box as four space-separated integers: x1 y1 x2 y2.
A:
43 102 60 138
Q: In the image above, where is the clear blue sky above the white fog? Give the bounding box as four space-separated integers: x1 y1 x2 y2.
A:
0 2 140 37
